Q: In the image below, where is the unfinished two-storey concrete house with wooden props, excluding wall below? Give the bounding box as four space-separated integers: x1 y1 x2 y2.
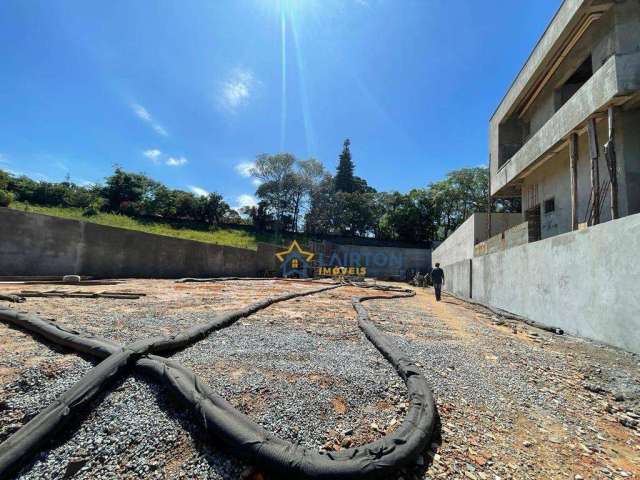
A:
489 0 640 241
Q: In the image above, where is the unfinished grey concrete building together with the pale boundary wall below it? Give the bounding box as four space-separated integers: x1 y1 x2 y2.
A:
432 0 640 353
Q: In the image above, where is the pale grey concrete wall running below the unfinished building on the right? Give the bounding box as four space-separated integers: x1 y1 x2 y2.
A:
445 214 640 353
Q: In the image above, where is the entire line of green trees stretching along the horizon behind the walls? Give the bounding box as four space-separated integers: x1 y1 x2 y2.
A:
0 139 520 243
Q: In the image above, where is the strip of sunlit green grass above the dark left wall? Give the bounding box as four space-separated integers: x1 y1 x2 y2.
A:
10 202 283 250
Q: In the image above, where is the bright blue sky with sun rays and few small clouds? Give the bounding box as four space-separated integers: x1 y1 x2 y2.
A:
0 0 560 210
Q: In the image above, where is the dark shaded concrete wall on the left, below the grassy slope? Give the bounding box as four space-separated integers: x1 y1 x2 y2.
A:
0 208 257 278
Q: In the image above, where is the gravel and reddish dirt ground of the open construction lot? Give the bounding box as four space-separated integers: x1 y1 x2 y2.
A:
0 280 640 480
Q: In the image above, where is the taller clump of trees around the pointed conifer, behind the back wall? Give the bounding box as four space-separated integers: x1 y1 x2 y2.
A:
242 139 520 242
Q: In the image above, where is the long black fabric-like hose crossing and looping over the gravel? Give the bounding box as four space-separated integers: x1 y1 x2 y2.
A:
0 284 436 479
